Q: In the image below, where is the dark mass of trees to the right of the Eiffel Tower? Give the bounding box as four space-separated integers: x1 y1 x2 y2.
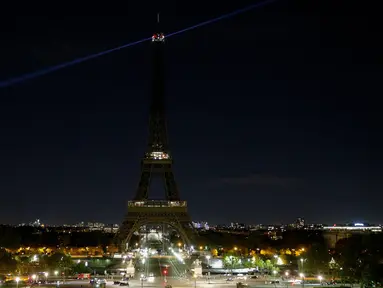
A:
204 230 383 285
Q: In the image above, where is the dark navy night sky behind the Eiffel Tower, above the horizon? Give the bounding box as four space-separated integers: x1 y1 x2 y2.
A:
0 0 383 224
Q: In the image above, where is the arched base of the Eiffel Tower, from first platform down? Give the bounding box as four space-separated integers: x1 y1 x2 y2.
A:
118 200 195 252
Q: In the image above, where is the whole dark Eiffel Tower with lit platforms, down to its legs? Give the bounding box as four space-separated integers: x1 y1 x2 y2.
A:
118 33 194 251
